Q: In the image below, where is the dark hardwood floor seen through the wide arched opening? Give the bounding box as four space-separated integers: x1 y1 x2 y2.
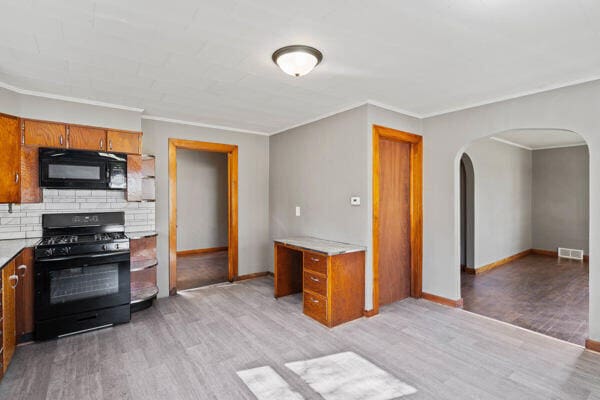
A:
461 255 589 345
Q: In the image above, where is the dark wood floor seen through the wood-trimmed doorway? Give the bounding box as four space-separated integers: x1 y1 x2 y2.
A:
177 250 228 290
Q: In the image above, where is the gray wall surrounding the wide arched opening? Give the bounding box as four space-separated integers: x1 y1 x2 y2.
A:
423 81 600 340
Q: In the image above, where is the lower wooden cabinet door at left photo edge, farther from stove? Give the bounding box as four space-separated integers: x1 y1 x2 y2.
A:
2 259 18 372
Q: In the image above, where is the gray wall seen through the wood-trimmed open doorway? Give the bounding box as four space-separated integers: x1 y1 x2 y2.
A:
177 149 228 251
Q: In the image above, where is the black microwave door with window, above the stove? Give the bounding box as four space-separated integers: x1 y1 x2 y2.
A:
39 149 109 189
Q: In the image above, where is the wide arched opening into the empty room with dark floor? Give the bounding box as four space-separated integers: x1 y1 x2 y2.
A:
459 129 589 346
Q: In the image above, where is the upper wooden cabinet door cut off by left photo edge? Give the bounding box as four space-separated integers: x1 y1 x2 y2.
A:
0 114 21 203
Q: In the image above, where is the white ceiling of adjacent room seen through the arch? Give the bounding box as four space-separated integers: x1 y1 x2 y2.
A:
492 129 586 150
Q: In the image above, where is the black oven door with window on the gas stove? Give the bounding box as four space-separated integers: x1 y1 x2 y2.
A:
35 251 131 321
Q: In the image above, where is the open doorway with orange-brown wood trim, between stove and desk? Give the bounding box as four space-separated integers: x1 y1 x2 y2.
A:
169 139 238 295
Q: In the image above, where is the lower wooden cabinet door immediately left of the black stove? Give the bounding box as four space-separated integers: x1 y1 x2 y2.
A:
15 247 33 342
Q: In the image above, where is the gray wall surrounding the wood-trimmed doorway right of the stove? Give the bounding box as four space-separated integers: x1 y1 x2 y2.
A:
142 120 273 297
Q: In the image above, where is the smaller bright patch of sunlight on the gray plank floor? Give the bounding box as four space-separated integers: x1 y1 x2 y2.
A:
237 366 304 400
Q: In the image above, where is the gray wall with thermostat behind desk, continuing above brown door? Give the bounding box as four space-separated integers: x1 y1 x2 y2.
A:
269 105 421 309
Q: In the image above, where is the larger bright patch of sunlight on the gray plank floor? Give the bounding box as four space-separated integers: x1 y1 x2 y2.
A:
285 352 417 400
